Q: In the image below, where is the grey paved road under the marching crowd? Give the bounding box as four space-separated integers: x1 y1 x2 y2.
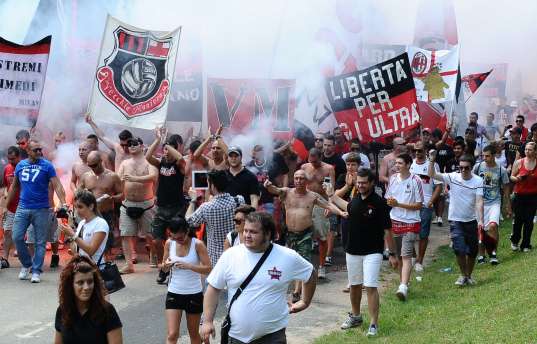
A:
0 225 447 344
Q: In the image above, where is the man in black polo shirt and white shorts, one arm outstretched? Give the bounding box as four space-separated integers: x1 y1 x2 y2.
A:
327 169 397 336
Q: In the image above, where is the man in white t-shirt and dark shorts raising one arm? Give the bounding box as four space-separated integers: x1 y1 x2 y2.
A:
429 150 483 287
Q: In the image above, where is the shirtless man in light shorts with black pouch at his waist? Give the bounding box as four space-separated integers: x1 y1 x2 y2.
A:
118 137 158 274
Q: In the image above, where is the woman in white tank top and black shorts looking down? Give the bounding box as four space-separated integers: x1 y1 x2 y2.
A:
162 218 211 344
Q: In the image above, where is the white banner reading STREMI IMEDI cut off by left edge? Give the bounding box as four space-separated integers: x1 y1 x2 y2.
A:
0 36 52 127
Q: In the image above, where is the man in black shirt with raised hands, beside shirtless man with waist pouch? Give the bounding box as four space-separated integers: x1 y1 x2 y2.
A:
145 128 186 284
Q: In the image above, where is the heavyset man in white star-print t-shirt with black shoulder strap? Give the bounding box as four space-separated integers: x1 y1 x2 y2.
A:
201 212 317 344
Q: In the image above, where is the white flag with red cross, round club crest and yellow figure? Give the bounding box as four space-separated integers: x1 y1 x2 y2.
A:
407 46 459 103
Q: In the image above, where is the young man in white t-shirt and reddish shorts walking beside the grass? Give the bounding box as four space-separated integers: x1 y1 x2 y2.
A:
384 153 423 301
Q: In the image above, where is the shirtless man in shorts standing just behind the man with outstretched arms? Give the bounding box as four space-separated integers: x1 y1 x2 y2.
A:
302 148 336 278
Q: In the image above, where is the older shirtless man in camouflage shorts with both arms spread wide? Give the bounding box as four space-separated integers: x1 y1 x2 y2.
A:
263 171 347 302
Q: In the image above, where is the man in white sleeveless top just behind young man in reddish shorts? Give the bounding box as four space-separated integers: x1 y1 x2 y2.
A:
410 141 442 272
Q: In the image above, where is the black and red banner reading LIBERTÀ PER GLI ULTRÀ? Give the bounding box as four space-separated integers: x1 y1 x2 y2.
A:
325 53 420 142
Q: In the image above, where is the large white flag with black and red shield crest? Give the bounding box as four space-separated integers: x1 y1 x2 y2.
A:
89 16 181 129
